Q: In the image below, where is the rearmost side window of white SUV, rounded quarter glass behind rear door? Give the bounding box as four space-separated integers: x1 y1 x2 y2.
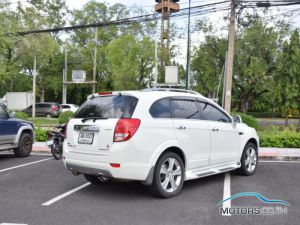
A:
149 98 171 118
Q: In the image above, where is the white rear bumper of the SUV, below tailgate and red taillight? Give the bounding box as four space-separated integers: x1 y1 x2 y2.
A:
63 141 151 181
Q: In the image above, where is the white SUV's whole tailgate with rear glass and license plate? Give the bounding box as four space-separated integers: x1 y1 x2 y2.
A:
67 94 138 155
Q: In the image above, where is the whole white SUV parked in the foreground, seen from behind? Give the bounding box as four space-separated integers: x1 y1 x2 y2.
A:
63 89 259 198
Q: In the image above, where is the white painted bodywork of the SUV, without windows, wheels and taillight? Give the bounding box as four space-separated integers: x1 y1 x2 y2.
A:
63 90 259 192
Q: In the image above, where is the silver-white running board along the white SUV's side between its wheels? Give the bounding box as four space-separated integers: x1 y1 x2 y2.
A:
185 162 241 180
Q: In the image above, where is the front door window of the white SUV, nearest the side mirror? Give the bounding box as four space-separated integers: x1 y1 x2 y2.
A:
197 102 231 123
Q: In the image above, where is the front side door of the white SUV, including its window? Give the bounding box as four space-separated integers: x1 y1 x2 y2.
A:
197 101 240 165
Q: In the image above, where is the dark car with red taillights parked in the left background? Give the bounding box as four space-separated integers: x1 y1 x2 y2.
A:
23 102 61 118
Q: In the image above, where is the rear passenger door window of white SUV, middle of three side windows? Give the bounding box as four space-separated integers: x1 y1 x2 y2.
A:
172 99 200 119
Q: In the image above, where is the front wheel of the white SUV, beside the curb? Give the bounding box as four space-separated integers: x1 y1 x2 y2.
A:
237 142 258 176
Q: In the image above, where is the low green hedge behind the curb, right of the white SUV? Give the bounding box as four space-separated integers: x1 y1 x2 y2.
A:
259 127 300 148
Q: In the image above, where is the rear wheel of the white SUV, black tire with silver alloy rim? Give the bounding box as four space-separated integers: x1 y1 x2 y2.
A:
150 152 184 198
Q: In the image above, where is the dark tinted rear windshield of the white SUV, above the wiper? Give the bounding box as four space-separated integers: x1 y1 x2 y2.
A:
75 95 138 119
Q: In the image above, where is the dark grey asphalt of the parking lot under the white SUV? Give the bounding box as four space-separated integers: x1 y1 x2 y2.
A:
0 154 300 225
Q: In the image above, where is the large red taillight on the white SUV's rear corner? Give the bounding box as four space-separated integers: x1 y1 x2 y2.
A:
114 119 141 142
